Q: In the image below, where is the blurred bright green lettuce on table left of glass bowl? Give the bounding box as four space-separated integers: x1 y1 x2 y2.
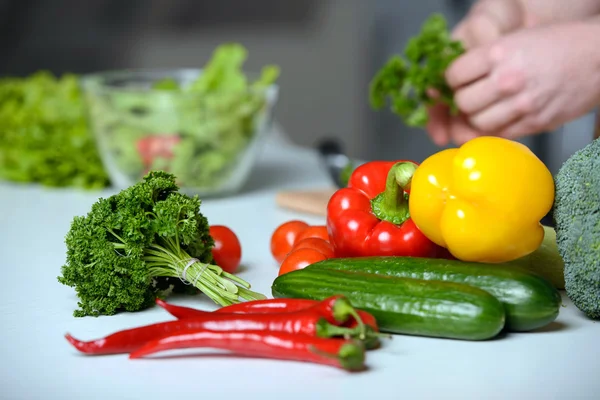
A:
0 71 109 189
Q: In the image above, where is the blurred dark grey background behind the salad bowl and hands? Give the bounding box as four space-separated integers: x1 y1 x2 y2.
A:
0 0 594 172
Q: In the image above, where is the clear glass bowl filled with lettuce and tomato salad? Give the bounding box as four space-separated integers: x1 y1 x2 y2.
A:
82 67 278 197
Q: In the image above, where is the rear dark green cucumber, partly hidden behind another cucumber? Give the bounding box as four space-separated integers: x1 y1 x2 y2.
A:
309 257 562 332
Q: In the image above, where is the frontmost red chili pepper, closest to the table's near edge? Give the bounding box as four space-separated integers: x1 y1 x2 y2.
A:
129 330 365 371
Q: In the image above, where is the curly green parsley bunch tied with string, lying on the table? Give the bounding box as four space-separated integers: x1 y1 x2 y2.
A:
58 171 264 317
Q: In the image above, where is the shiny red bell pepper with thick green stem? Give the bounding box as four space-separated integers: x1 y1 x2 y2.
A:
327 161 440 257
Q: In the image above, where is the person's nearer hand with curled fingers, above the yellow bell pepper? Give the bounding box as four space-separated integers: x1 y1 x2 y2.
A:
427 22 600 145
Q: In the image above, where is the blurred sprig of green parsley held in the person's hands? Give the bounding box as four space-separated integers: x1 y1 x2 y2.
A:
369 14 464 127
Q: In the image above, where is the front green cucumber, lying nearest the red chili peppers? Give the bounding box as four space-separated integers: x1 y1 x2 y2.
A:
271 268 505 340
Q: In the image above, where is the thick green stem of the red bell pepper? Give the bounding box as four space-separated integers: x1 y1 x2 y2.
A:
371 161 417 225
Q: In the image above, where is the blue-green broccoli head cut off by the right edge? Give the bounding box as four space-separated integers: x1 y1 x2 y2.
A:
554 139 600 319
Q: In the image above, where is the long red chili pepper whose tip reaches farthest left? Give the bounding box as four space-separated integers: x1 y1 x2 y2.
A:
65 308 367 354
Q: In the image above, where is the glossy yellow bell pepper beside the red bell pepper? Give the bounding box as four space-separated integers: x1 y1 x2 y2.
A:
409 136 554 263
